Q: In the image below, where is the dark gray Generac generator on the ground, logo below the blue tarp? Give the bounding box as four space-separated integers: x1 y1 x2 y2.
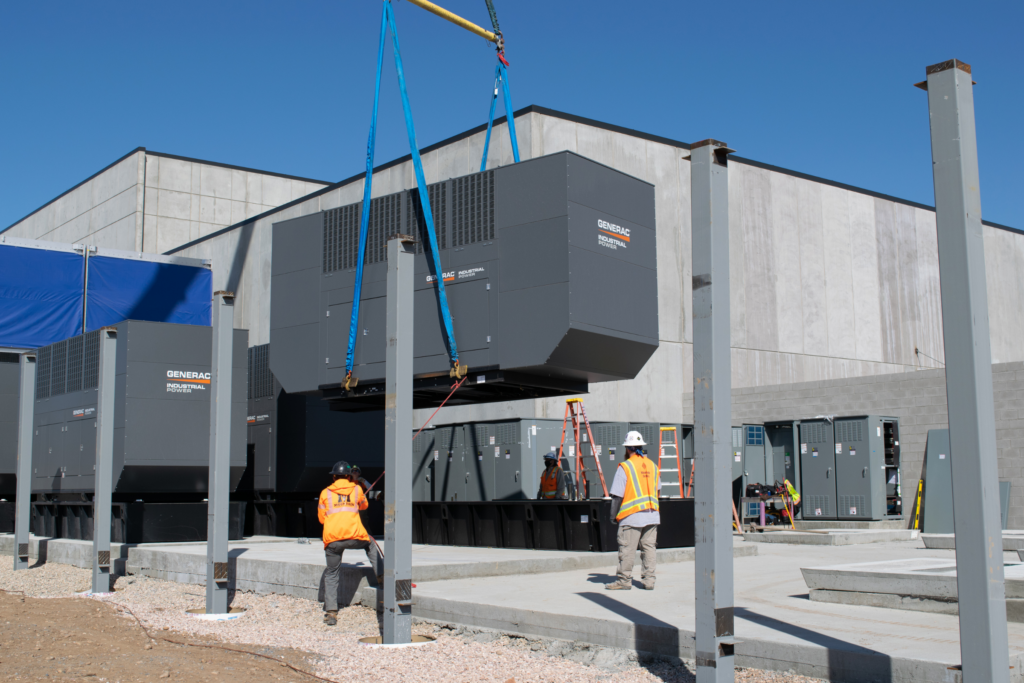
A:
32 321 249 495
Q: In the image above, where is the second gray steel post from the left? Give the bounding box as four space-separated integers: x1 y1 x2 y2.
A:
92 328 118 593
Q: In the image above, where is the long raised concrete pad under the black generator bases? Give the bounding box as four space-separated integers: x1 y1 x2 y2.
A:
127 539 757 604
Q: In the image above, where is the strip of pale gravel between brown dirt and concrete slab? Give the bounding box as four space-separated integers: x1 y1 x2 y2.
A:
0 563 817 683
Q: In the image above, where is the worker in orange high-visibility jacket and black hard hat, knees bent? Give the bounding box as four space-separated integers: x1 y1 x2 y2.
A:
317 460 384 626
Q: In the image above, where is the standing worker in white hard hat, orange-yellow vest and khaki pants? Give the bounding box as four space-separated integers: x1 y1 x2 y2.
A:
604 431 662 591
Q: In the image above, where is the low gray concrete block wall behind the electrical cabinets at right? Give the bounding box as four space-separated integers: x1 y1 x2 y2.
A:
683 362 1024 529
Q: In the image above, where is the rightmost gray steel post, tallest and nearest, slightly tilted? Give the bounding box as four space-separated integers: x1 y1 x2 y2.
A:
919 59 1010 683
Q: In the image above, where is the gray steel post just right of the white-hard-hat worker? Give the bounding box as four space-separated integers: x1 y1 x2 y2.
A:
690 140 735 683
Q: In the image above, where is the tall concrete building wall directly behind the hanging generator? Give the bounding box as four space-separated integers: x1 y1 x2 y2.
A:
167 109 1024 430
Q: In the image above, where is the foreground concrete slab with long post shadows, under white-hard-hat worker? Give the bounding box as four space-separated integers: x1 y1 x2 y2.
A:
403 541 1024 683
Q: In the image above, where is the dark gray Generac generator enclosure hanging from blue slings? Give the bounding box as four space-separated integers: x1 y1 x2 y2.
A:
270 152 658 409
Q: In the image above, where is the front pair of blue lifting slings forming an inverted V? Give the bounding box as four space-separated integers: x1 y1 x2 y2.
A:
344 0 462 390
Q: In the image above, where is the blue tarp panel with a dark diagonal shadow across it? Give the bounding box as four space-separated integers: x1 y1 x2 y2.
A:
85 256 213 332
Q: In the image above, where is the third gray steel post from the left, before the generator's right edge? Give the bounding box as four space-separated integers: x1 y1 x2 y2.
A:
206 292 234 614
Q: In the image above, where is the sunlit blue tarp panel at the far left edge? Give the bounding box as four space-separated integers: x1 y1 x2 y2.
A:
0 245 83 348
